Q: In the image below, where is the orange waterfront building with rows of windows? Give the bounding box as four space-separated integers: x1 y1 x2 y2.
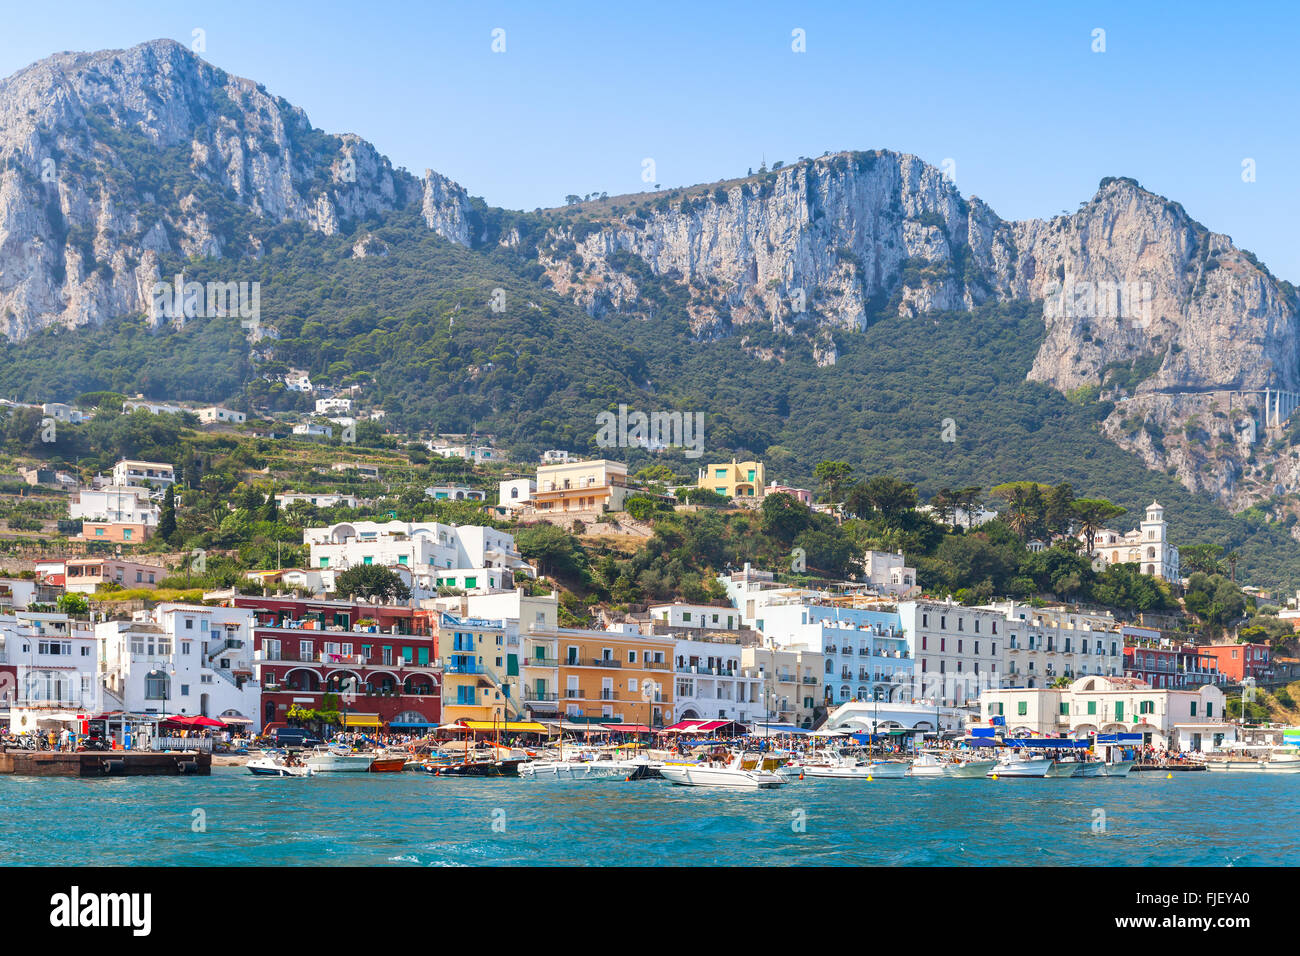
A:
530 627 673 727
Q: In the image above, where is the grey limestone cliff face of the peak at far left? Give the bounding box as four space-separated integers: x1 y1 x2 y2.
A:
0 40 469 338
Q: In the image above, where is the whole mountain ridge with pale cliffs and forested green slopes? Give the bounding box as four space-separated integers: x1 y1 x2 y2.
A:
0 40 1300 567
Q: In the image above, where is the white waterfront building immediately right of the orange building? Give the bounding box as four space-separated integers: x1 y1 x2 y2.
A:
672 637 764 723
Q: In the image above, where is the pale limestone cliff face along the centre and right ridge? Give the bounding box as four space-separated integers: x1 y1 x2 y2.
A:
540 151 1300 520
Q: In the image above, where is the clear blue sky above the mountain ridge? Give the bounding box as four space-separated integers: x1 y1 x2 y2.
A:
0 0 1300 281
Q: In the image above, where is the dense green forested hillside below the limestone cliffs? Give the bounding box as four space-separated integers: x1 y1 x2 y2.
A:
0 201 1300 589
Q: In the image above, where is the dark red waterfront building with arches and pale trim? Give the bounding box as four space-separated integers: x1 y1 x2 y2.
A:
234 597 442 732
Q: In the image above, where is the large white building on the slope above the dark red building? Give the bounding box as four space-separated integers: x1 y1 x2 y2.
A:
303 522 536 596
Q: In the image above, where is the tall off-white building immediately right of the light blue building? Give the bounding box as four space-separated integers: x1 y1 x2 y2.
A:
898 601 1008 708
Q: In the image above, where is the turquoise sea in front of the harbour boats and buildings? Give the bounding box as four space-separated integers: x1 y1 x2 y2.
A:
0 767 1300 866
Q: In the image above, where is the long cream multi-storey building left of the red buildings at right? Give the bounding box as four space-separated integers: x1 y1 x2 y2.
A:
987 601 1125 687
